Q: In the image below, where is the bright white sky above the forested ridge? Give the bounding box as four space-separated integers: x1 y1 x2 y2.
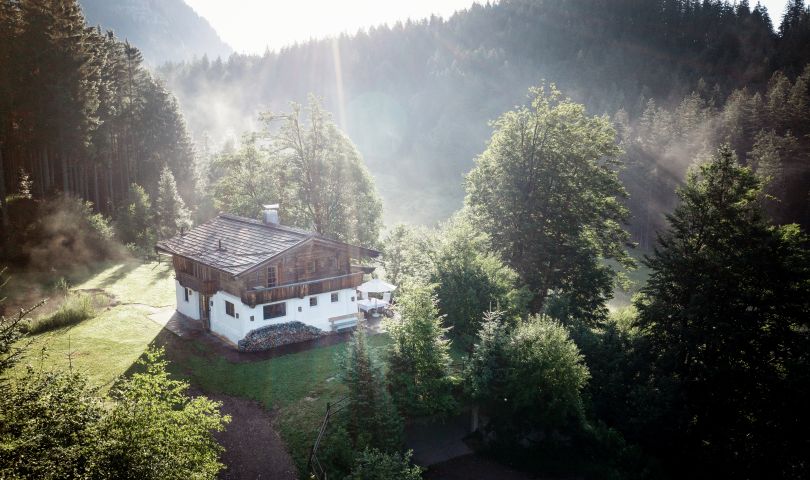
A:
186 0 474 53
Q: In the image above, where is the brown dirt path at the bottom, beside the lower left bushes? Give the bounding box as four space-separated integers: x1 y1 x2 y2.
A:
192 391 298 480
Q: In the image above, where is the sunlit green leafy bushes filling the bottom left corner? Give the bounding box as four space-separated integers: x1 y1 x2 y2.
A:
0 343 229 480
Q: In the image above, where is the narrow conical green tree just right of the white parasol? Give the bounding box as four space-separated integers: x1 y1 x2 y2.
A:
387 284 456 416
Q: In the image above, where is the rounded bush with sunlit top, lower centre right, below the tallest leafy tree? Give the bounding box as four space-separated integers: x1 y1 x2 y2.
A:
467 315 589 447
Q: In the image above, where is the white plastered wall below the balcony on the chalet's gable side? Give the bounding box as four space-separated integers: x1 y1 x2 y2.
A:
205 288 357 343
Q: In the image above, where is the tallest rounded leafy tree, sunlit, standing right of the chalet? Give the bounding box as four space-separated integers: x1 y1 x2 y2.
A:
466 86 632 319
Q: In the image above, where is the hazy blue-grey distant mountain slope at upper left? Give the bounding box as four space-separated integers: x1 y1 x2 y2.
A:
79 0 233 66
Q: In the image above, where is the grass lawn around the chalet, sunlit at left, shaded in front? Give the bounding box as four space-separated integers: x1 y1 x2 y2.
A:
11 262 389 478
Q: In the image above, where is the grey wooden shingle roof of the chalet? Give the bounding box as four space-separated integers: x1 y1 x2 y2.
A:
155 213 379 275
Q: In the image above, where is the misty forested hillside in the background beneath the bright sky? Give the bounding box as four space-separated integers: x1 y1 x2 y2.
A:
161 0 810 227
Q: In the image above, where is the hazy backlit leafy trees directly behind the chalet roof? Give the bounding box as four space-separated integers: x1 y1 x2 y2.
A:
209 96 382 247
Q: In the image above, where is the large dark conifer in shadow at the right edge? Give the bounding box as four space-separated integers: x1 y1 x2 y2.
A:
636 147 810 477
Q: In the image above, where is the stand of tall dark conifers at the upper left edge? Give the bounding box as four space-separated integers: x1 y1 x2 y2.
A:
0 0 196 259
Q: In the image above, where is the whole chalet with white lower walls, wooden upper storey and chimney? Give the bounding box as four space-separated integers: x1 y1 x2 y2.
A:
155 205 379 350
